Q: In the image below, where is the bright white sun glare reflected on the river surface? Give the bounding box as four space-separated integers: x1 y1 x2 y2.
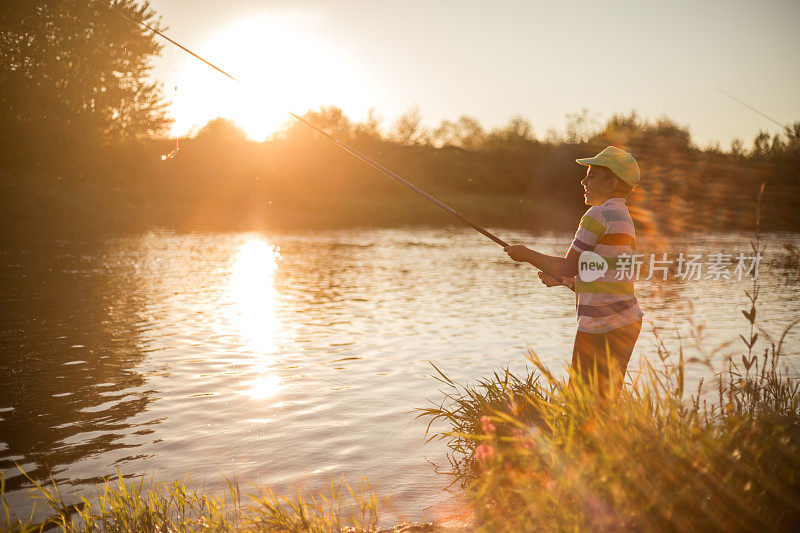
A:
230 239 281 399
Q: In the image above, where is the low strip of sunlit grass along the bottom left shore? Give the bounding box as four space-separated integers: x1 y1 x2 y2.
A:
0 472 380 533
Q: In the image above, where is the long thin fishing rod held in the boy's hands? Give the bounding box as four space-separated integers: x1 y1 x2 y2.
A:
106 3 572 289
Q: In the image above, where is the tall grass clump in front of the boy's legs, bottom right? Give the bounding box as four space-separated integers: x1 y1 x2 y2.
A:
421 330 800 531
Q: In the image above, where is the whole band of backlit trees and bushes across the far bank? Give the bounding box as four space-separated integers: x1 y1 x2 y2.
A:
0 0 800 233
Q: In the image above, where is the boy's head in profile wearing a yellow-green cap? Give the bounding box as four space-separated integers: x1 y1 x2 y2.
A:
575 146 641 205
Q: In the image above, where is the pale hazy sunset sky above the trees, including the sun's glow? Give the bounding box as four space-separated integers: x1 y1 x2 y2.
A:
151 0 800 148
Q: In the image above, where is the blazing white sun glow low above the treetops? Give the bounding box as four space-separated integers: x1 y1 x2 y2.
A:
169 14 369 141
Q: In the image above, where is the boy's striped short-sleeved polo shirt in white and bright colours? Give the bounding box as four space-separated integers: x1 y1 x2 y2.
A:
572 198 643 333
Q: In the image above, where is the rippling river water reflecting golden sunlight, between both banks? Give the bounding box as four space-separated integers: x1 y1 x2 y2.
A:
0 229 800 523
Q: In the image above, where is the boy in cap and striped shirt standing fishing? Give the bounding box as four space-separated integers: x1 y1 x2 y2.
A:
504 146 642 401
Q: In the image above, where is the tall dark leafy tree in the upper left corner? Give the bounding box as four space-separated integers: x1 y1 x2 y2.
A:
0 0 169 166
